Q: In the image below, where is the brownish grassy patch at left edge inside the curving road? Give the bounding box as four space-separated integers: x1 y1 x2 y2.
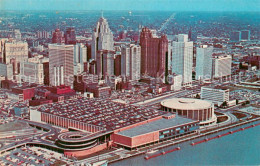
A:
0 121 30 132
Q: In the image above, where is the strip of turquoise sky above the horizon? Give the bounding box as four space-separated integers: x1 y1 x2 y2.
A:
0 0 260 11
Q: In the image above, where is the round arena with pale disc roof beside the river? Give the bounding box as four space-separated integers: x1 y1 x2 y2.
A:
161 98 217 126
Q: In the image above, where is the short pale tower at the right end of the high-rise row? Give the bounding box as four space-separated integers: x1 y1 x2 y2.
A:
212 55 232 78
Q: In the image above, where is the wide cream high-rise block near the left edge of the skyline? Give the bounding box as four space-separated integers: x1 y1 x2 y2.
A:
3 41 28 75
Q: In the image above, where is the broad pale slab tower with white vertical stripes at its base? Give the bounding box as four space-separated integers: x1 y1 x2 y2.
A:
49 44 74 86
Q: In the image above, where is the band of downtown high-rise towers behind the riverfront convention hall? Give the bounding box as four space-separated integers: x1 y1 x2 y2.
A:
1 17 232 91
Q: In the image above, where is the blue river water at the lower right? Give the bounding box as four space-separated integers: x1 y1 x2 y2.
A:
110 122 260 166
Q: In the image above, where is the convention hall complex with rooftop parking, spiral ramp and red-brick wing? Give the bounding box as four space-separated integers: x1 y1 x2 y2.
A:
30 97 199 157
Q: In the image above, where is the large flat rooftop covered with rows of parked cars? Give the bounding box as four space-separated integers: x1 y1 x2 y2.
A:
38 97 165 130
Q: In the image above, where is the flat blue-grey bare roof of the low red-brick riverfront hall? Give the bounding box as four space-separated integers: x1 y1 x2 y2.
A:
118 116 196 137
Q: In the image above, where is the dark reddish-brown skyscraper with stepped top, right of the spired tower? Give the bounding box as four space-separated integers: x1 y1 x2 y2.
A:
140 27 168 77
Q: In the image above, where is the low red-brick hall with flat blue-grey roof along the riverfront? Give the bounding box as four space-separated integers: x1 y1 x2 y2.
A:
112 113 199 149
